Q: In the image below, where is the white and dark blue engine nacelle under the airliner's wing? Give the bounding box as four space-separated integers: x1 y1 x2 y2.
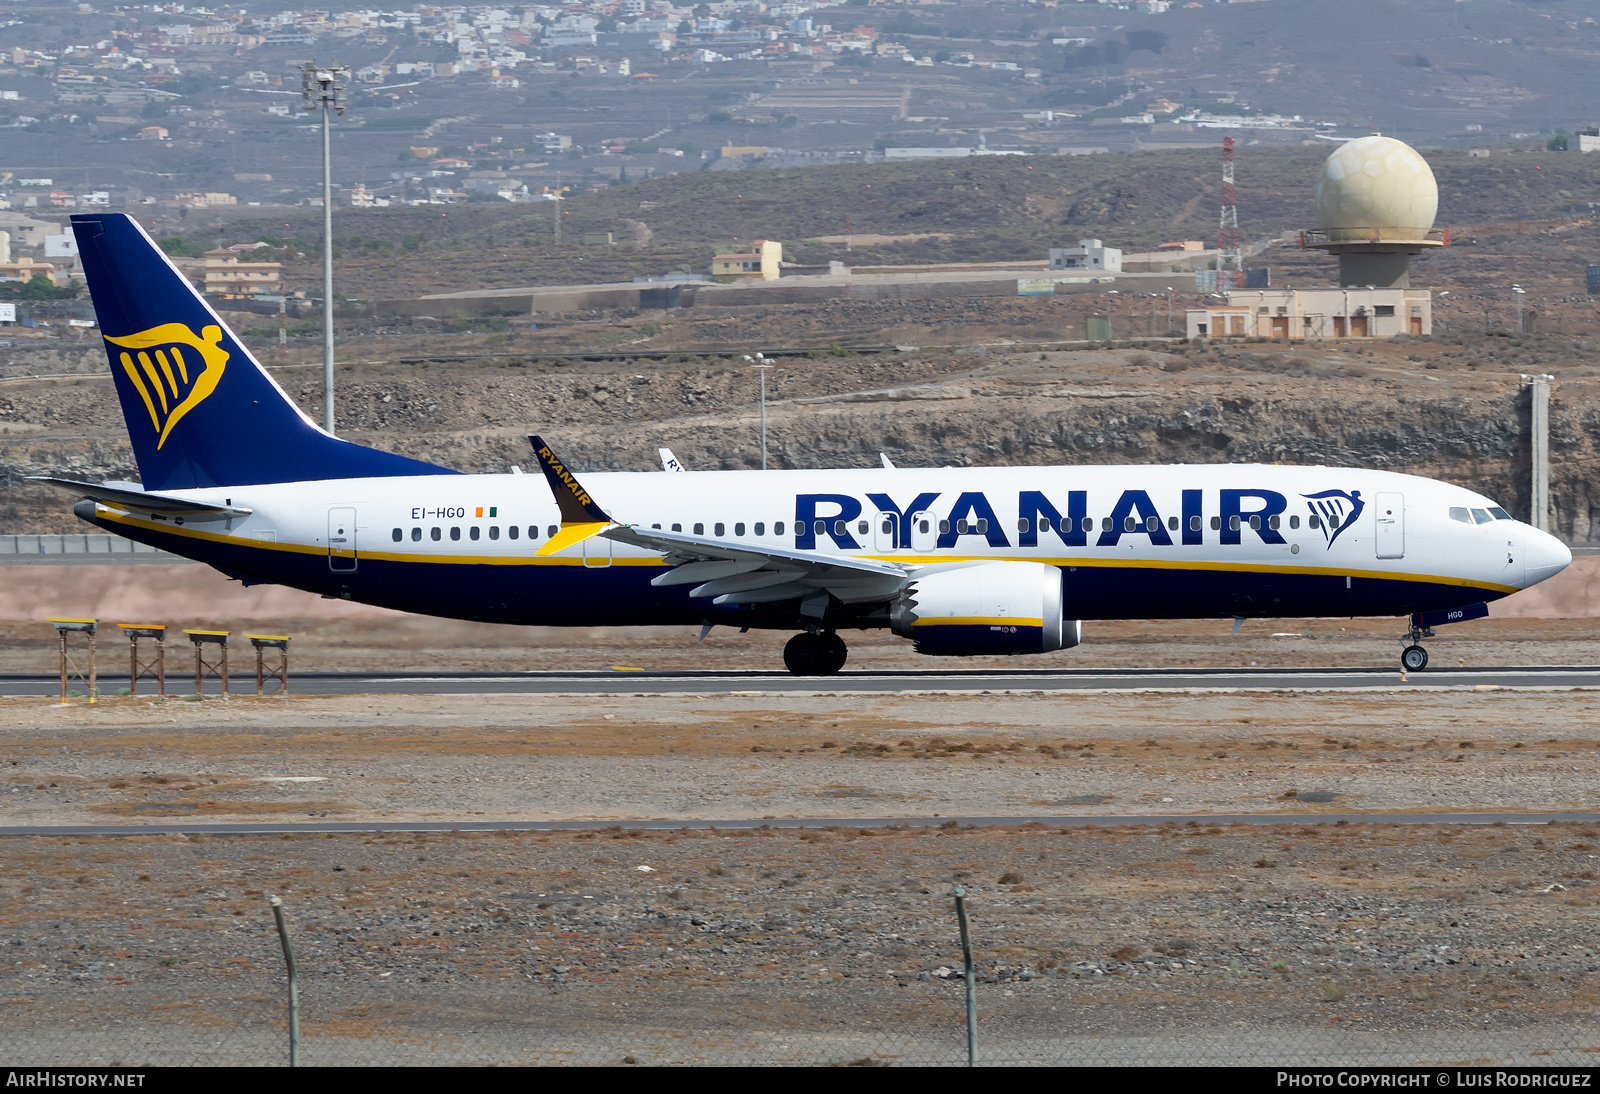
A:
890 561 1083 657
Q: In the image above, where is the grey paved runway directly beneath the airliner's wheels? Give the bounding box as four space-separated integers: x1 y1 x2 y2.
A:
9 665 1600 696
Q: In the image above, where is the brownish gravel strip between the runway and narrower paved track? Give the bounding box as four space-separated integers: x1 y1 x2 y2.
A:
0 686 1600 824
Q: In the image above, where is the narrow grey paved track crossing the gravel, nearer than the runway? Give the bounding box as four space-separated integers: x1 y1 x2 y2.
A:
0 813 1600 836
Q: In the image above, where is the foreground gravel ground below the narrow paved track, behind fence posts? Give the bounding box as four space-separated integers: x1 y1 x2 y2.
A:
0 822 1600 1065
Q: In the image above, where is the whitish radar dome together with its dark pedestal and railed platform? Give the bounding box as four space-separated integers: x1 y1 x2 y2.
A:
1304 133 1448 288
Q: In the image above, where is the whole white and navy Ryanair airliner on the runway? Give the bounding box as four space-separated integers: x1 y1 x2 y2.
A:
48 214 1571 675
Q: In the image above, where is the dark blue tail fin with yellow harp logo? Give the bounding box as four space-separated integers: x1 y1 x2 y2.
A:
72 213 454 489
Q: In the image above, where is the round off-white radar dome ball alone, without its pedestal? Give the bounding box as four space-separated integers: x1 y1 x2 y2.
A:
1317 134 1438 240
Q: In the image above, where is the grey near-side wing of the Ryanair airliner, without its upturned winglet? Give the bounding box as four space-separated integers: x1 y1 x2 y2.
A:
600 525 910 616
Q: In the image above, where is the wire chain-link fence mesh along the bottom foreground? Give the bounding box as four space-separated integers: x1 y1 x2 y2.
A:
0 904 1600 1067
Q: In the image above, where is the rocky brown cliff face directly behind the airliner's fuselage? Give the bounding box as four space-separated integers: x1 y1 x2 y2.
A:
0 347 1600 542
